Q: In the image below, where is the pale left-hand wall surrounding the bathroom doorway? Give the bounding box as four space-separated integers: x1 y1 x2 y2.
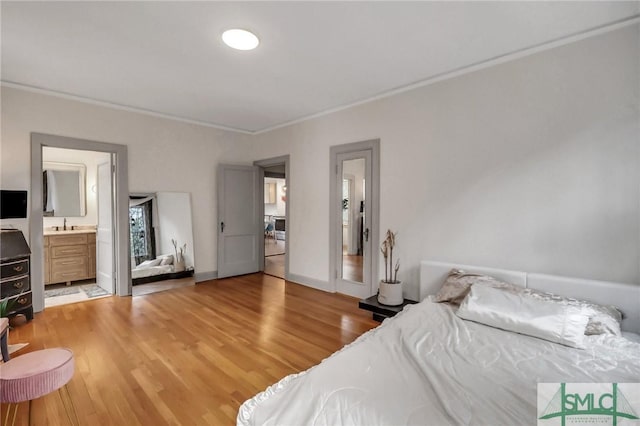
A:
0 87 248 280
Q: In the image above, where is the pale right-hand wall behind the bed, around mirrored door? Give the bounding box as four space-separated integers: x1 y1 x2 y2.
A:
251 25 640 297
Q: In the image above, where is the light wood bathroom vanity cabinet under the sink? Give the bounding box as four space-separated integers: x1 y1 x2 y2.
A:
44 230 96 284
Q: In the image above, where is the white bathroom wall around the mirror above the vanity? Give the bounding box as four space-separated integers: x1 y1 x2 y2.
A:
42 147 110 228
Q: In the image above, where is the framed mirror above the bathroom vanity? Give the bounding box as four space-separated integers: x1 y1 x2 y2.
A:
42 161 87 217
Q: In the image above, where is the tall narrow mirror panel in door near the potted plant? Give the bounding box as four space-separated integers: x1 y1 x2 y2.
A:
342 158 365 283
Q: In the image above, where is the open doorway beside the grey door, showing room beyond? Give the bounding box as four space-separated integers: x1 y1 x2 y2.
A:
254 156 290 279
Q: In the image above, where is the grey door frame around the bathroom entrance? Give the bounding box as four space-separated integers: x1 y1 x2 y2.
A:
29 133 131 312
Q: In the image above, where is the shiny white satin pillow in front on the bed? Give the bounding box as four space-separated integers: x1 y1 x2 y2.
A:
457 285 592 348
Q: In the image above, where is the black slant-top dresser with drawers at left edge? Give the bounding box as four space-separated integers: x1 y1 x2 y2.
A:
0 229 33 320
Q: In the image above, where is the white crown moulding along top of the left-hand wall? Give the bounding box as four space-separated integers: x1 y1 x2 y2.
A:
0 80 254 135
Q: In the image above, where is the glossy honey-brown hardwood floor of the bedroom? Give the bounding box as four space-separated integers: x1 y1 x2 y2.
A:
2 274 378 426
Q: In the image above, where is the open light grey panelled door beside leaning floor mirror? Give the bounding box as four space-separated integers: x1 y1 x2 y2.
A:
218 164 264 278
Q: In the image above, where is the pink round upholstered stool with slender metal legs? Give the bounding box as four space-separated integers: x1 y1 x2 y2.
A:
0 348 78 425
